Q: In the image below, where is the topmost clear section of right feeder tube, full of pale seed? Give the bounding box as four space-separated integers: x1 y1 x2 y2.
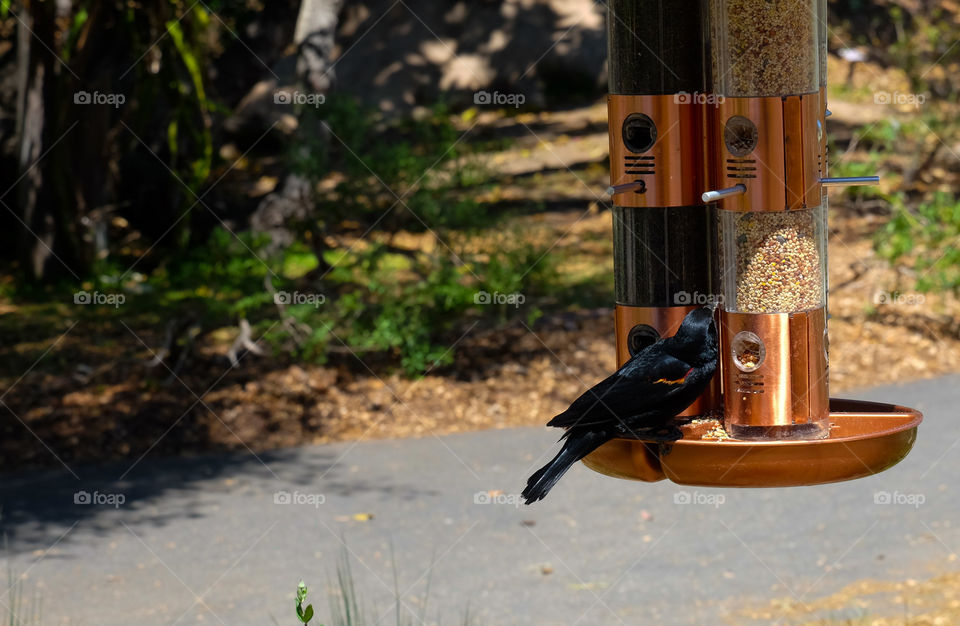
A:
705 0 821 97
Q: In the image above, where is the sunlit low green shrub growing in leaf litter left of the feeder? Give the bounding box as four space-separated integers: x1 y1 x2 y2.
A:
289 234 557 375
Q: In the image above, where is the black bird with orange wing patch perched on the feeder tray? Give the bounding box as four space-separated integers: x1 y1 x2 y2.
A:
522 307 717 504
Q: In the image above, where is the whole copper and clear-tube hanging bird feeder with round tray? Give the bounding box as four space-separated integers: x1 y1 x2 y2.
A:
584 0 922 487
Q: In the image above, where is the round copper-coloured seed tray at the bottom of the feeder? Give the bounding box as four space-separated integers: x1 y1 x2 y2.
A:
583 398 923 487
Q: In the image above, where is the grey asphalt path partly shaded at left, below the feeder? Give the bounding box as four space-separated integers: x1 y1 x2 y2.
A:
0 376 960 626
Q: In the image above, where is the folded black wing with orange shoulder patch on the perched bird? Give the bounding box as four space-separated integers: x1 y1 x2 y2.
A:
547 351 693 428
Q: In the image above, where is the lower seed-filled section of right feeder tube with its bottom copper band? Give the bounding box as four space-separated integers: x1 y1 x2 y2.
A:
719 206 829 440
